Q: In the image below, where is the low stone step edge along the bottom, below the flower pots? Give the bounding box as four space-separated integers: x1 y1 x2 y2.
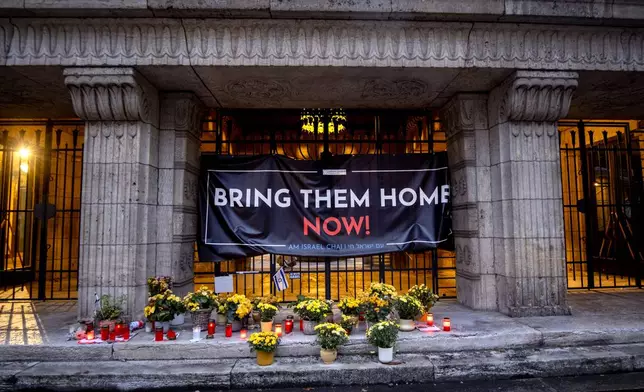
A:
0 344 644 390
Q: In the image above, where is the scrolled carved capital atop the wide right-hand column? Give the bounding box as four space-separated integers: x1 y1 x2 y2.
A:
488 70 579 126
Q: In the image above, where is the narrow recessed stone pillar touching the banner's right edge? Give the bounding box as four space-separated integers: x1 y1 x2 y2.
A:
441 94 498 310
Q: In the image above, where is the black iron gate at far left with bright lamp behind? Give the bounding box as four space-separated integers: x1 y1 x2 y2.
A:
0 120 83 300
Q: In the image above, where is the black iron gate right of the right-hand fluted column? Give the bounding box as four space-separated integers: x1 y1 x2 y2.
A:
559 121 644 288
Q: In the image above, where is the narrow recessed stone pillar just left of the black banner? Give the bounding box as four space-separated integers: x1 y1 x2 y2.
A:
155 92 203 295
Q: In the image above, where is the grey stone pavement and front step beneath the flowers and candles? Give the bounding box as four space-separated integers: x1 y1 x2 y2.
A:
0 290 644 390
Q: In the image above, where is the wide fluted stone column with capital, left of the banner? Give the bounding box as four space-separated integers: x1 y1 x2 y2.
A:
64 68 159 317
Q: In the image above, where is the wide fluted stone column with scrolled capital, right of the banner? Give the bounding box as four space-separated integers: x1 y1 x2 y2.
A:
488 71 578 316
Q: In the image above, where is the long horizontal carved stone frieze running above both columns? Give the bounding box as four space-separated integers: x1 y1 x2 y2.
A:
0 18 644 71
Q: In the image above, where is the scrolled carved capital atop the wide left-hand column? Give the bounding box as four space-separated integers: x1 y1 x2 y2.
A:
64 68 159 126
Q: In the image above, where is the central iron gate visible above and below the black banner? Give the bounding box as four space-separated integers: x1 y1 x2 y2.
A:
194 110 456 301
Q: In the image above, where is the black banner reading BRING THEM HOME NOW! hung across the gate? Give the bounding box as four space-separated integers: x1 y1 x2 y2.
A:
199 153 452 261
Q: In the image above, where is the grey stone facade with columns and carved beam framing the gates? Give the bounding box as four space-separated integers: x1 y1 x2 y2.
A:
0 0 644 316
